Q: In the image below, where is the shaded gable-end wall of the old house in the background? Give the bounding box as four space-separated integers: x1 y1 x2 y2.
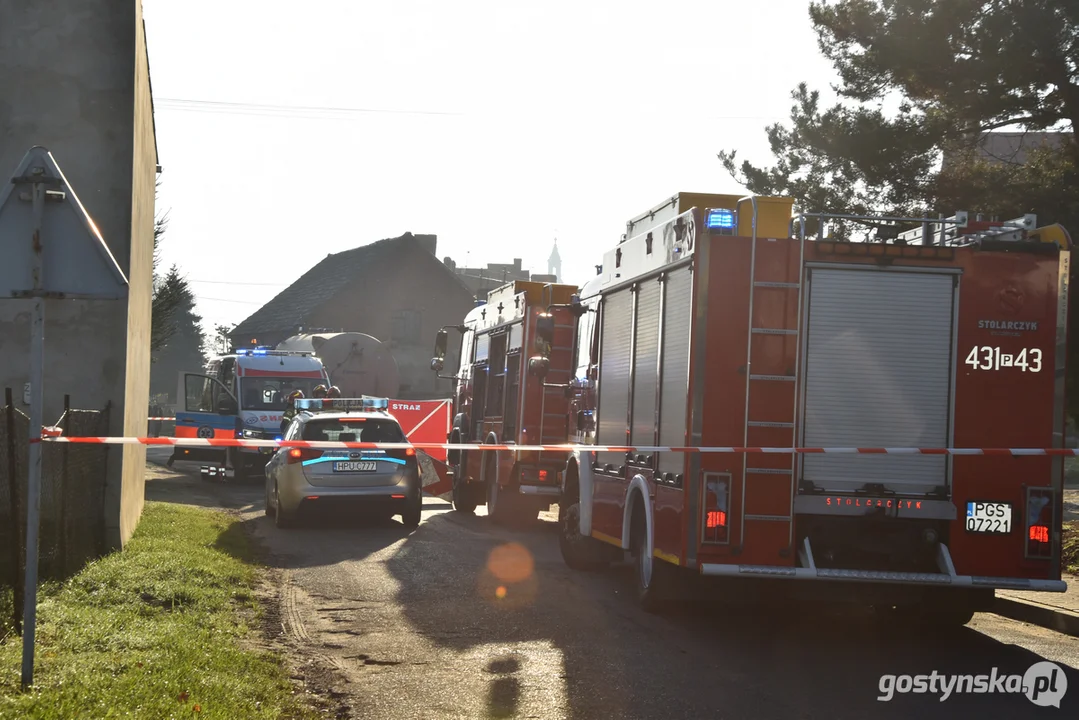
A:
310 243 475 399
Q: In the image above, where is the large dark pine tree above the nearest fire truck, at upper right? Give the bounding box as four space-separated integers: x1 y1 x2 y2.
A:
719 0 1079 418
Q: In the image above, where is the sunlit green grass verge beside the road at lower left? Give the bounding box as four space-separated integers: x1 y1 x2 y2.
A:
0 503 313 720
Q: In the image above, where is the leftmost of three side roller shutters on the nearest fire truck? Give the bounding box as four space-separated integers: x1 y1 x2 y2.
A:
597 287 633 467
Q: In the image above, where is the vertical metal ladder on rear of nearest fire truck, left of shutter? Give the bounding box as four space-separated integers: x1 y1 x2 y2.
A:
735 195 805 548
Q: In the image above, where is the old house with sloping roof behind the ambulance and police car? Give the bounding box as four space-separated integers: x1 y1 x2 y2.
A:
230 233 475 399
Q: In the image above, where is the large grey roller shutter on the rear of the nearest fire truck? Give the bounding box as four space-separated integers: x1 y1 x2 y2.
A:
802 268 955 493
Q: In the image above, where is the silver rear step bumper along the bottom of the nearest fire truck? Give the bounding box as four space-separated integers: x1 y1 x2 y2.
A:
700 539 1068 593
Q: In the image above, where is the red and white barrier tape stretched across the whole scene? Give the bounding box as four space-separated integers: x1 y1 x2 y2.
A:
27 437 1079 457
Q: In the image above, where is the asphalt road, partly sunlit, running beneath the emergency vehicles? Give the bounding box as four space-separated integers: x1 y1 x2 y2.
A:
148 451 1079 720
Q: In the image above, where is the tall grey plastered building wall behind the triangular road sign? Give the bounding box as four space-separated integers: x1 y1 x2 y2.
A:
0 0 156 547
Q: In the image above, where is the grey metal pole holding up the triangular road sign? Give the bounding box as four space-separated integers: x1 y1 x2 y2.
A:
23 167 45 689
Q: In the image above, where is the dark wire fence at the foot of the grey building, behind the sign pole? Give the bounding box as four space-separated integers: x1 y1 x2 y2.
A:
0 389 109 634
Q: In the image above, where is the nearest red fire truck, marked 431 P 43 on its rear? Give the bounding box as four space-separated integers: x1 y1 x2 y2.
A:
559 193 1071 623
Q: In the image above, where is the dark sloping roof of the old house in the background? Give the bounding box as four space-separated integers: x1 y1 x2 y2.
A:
230 232 467 338
